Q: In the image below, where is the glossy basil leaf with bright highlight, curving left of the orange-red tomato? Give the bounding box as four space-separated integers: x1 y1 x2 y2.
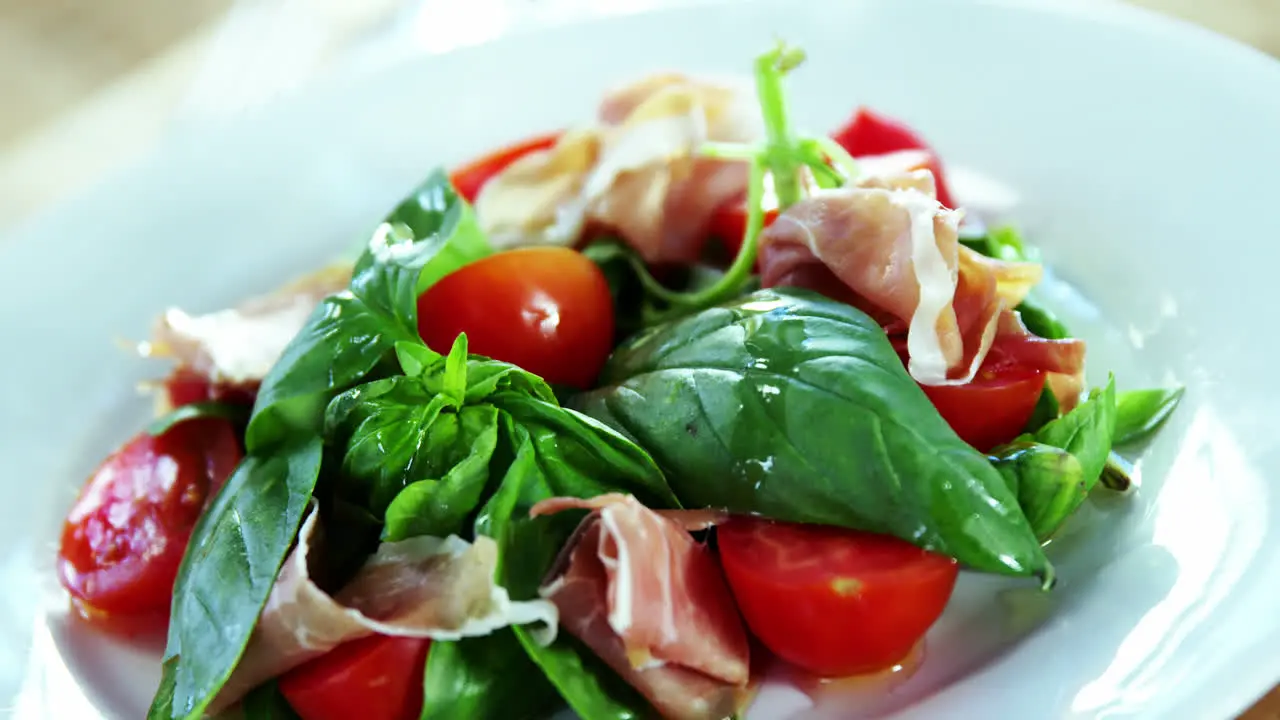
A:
247 170 492 451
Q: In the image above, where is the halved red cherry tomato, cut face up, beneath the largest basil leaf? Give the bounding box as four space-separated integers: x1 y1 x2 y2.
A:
716 516 957 678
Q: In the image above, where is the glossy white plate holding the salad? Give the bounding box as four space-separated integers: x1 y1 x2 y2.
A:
0 0 1280 720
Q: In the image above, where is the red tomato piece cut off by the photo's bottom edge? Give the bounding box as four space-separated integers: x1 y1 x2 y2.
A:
278 635 431 720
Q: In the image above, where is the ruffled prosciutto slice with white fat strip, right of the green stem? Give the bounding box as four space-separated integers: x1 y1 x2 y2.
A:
760 165 1084 406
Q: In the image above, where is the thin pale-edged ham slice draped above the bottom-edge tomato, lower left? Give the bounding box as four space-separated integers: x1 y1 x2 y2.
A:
210 502 559 712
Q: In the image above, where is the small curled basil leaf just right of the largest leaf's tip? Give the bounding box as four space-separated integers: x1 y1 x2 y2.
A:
991 442 1088 542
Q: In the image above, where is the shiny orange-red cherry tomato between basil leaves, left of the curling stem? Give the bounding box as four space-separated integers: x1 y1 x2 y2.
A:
417 247 613 388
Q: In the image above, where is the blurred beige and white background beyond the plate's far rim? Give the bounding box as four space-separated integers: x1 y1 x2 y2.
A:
0 0 1280 229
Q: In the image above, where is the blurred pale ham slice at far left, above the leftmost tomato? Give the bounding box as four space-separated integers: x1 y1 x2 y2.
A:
138 264 351 388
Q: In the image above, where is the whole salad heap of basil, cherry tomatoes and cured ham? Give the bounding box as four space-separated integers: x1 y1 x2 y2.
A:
58 44 1181 720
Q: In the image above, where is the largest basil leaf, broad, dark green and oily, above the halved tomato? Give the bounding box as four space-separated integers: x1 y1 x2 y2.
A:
575 288 1052 582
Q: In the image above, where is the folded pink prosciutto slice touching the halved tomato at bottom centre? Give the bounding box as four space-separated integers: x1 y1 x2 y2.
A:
531 495 750 720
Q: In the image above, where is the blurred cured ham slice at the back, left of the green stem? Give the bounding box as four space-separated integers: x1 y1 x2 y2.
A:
476 73 760 263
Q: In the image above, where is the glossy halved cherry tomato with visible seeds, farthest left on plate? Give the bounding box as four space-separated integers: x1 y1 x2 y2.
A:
58 418 241 620
